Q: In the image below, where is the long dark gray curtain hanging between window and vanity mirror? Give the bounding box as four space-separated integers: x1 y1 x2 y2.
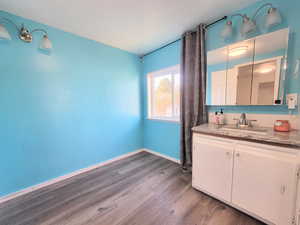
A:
180 24 208 171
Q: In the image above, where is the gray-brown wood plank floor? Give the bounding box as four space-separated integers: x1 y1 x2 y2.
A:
0 152 263 225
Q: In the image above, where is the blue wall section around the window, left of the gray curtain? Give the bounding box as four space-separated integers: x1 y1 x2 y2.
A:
143 41 181 159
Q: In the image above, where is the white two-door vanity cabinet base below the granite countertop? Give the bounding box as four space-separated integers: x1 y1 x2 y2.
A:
193 133 300 225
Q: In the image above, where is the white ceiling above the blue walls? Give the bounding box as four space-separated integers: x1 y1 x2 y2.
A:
0 0 257 55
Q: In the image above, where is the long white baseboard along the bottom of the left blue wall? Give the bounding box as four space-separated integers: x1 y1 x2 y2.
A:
0 149 144 204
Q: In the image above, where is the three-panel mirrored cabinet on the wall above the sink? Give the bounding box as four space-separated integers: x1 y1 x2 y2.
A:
206 29 289 105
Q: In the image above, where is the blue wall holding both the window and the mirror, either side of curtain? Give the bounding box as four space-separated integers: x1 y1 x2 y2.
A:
143 0 300 158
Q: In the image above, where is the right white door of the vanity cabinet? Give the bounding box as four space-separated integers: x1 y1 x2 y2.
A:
232 145 297 225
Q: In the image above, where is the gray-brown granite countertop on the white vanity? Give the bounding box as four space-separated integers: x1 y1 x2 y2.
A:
192 124 300 150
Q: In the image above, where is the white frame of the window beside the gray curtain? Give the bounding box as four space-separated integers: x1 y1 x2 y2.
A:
147 65 181 122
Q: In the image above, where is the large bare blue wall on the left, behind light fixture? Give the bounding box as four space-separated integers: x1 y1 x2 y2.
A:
0 12 143 196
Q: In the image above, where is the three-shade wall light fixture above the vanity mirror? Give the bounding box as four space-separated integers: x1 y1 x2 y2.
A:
221 3 282 39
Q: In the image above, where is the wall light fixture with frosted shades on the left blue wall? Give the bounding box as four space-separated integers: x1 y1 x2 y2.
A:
0 17 52 50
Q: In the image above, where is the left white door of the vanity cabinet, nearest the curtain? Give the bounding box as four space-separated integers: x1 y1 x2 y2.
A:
193 136 233 202
